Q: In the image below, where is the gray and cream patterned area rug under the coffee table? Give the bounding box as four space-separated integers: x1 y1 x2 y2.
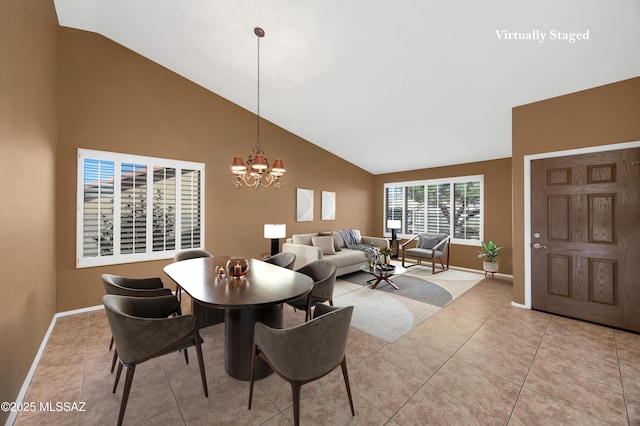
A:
333 268 484 343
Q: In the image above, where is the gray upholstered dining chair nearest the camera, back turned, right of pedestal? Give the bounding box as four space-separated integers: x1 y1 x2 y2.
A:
249 305 356 426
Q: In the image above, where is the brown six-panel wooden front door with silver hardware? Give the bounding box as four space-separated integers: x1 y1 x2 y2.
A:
531 148 640 332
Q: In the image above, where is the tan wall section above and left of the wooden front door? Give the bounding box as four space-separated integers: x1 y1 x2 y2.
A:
512 77 640 303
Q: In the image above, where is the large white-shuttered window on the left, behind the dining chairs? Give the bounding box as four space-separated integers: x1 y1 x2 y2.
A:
76 149 204 268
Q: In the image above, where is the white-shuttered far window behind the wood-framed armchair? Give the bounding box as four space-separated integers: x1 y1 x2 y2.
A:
384 176 484 245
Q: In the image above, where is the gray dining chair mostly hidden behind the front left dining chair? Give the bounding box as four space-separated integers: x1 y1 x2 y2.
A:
102 274 181 373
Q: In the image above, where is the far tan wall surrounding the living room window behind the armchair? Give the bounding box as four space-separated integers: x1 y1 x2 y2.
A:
373 158 512 274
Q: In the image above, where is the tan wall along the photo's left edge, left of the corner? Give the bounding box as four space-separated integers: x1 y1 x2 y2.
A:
0 0 58 424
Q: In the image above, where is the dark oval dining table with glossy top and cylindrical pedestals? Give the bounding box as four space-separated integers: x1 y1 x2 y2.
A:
164 256 313 381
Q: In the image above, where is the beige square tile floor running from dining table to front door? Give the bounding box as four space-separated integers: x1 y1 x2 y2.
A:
10 279 640 426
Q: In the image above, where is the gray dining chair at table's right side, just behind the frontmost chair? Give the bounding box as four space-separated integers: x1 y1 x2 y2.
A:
287 260 338 321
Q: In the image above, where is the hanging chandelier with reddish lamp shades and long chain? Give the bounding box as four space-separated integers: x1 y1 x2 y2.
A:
231 27 285 189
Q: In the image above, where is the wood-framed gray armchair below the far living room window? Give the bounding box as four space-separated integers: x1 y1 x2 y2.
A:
400 232 451 274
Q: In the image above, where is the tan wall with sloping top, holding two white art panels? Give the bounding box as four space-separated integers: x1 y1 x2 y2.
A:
56 28 373 311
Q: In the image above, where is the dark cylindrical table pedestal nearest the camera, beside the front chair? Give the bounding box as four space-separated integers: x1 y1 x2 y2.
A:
224 304 282 381
